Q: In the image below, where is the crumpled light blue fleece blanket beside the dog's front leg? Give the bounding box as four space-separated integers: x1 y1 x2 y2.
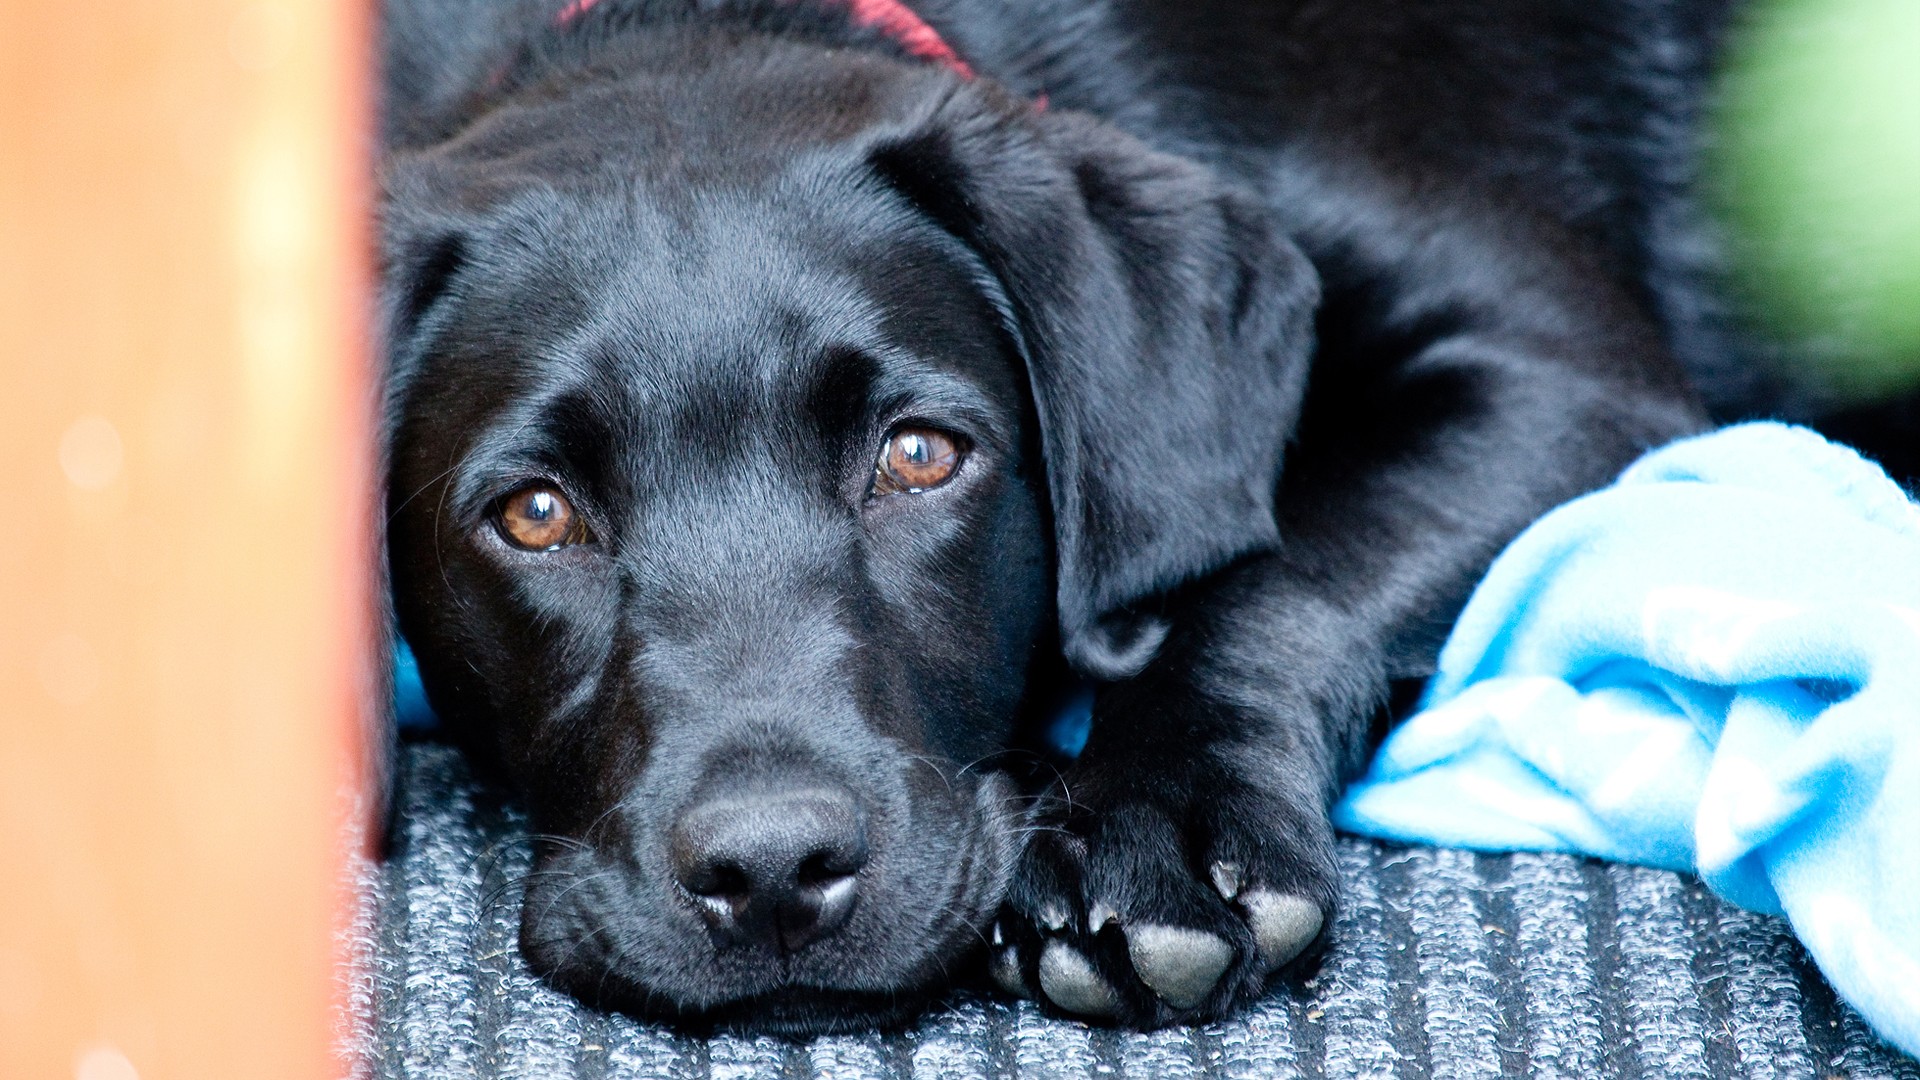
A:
1336 425 1920 1055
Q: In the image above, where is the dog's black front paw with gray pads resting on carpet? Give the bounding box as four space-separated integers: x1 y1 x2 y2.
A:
991 760 1334 1028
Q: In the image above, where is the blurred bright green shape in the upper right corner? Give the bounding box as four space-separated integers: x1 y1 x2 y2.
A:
1709 0 1920 405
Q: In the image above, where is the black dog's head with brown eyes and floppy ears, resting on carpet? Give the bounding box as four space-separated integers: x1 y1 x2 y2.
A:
384 29 1315 1032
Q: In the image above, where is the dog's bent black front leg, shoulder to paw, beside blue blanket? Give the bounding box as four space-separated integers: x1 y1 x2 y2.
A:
993 205 1697 1026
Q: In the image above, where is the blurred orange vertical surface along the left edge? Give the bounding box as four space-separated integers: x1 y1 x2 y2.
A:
0 0 371 1080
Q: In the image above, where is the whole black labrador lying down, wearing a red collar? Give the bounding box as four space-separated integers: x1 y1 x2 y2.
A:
382 0 1724 1034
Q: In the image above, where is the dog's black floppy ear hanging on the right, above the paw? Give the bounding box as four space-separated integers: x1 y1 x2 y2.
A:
870 100 1319 678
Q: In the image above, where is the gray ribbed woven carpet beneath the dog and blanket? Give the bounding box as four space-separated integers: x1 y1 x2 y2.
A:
349 746 1920 1080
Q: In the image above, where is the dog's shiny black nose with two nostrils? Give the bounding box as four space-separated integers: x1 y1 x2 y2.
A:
672 788 866 953
